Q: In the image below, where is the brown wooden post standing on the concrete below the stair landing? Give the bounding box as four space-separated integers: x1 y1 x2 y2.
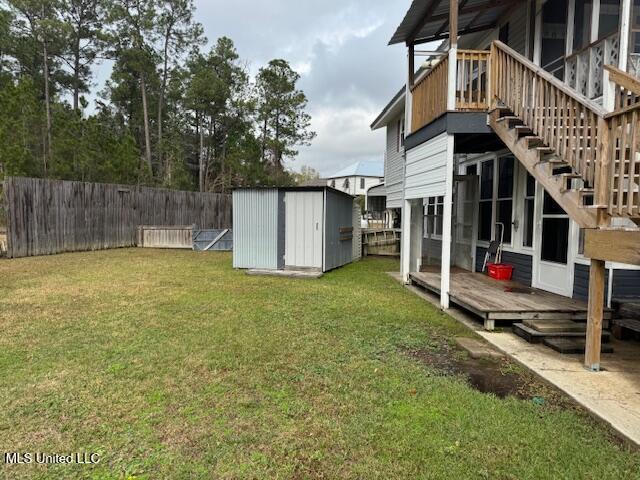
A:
584 259 605 372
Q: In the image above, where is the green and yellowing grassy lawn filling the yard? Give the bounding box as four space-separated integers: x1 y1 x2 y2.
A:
0 249 640 479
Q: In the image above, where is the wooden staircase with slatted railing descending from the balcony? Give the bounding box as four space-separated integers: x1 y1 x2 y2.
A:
489 42 640 229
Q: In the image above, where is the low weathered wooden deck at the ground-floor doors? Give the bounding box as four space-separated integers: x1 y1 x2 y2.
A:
410 268 611 330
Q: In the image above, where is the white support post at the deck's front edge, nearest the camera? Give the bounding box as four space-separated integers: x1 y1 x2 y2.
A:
440 133 455 309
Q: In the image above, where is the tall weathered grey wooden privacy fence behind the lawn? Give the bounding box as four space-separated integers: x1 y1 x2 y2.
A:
4 177 232 258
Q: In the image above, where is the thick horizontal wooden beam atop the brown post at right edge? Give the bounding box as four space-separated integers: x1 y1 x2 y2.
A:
584 229 640 266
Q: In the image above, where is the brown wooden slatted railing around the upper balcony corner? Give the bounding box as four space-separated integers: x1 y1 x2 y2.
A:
411 50 490 132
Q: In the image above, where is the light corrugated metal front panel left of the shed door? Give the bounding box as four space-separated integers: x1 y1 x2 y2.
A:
233 189 279 269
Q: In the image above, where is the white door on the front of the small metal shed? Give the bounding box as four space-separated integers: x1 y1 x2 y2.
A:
284 192 323 269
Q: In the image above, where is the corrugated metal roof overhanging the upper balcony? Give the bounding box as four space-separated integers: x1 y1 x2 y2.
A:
389 0 526 45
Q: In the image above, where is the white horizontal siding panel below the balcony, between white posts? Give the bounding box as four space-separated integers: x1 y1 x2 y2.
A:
404 133 447 200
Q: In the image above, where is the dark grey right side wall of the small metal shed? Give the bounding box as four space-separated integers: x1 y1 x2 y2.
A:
324 190 356 271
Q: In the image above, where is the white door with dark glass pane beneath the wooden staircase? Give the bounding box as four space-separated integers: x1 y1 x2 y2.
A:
533 185 574 297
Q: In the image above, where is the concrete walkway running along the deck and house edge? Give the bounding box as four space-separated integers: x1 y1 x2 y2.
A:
391 273 640 446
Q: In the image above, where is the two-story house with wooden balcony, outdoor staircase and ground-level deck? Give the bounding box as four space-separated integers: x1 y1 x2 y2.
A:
372 0 640 370
